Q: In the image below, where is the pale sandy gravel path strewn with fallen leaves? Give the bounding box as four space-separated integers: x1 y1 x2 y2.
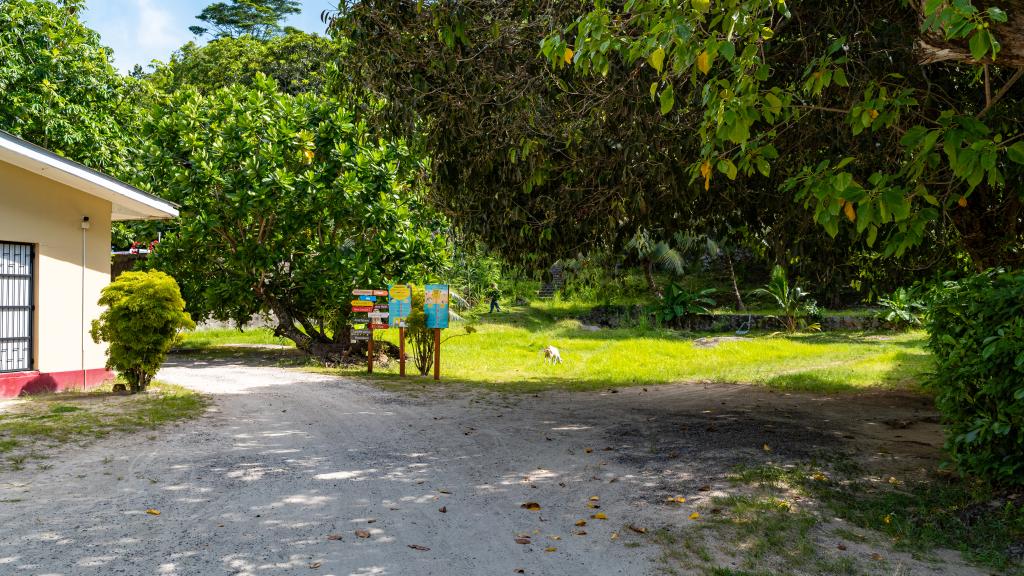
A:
0 358 958 575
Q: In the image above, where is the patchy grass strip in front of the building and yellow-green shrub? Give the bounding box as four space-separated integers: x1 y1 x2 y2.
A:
0 382 207 469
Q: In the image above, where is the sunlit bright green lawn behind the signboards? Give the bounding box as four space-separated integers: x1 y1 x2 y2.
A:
183 302 931 393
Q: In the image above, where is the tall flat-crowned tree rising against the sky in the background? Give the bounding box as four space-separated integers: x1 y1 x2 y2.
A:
188 0 302 40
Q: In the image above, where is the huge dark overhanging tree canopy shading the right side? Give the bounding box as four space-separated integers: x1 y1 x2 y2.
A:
334 0 1024 269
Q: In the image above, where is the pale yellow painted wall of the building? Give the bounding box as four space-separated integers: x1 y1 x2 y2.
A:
0 162 112 372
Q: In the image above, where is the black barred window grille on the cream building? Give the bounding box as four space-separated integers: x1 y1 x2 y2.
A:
0 242 36 372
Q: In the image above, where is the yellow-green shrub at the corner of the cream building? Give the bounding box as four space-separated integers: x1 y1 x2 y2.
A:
92 271 196 394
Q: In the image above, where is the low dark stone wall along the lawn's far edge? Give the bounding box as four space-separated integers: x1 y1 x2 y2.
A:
580 304 891 332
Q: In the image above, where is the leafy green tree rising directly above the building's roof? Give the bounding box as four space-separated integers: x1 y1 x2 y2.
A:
0 0 143 170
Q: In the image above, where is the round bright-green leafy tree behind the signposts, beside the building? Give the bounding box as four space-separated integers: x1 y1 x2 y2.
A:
145 75 443 361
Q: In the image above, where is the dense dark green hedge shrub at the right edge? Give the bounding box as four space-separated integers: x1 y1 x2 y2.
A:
926 272 1024 484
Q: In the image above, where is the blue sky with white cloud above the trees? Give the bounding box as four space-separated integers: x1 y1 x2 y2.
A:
82 0 337 73
